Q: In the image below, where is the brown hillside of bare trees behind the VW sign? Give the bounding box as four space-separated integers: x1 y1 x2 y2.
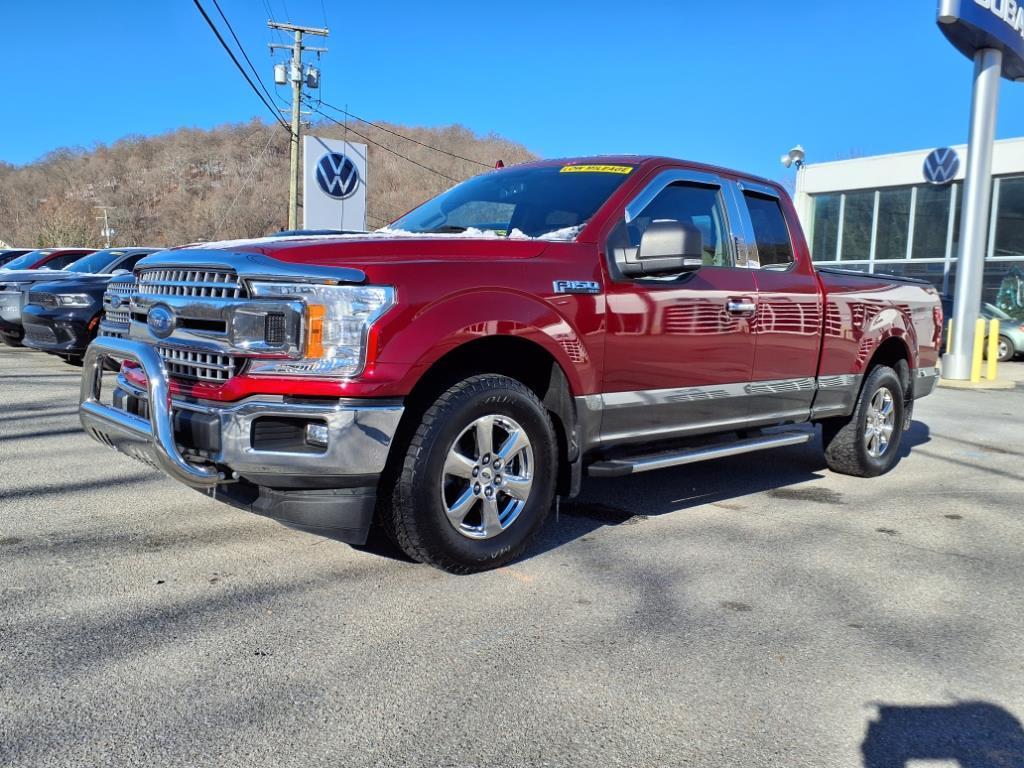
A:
0 121 532 247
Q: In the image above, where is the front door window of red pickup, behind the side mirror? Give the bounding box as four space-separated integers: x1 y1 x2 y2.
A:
608 182 733 276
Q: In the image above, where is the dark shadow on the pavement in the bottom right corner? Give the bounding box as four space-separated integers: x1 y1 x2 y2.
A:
860 701 1024 768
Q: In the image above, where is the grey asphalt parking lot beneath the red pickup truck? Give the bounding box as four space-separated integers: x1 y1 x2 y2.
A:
0 347 1024 768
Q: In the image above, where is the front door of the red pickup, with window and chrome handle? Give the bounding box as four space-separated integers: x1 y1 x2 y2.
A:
601 169 756 443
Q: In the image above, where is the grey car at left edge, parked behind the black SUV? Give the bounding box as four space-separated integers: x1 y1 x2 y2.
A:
0 248 143 346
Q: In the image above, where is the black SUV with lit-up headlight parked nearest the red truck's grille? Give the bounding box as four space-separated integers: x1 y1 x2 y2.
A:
22 248 157 364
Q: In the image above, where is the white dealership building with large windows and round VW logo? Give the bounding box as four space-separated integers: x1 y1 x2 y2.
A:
795 138 1024 318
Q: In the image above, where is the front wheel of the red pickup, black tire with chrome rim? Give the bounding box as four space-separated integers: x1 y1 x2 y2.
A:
381 374 558 573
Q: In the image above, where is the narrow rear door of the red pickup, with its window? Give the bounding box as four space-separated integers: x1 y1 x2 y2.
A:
733 182 823 424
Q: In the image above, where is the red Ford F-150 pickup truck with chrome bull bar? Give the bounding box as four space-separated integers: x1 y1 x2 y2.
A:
81 157 942 572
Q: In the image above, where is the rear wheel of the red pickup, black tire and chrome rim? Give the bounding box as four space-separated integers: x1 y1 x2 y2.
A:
821 366 905 477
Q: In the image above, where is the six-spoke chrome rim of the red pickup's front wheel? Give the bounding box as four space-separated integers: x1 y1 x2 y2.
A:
441 415 534 540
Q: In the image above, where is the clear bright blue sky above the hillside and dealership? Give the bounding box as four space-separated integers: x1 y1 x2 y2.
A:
6 0 1024 185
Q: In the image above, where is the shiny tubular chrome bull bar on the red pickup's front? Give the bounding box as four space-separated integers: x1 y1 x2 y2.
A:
79 336 225 488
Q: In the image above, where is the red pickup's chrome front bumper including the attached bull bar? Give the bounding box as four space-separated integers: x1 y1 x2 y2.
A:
79 337 403 543
